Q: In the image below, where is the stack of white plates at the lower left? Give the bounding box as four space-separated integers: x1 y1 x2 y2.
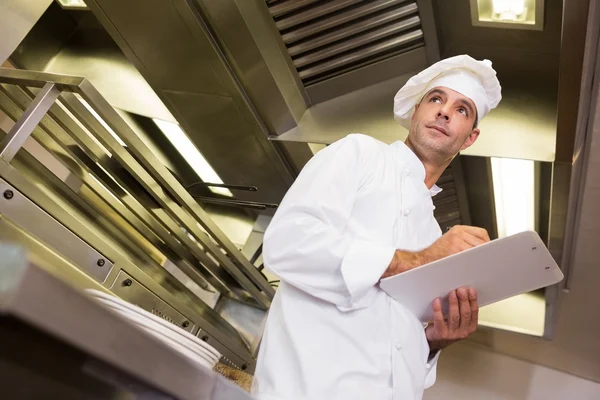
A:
86 289 221 369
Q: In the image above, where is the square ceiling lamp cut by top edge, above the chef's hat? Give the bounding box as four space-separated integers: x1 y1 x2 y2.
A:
471 0 544 31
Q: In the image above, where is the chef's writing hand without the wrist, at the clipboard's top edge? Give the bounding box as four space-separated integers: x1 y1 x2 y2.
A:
420 225 490 264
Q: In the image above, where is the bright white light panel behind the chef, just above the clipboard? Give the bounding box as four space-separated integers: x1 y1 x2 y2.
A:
491 157 535 237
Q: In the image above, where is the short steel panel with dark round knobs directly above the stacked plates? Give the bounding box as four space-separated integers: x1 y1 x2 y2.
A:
109 270 196 332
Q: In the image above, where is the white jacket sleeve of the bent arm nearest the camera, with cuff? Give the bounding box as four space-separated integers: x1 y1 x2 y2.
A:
263 134 395 310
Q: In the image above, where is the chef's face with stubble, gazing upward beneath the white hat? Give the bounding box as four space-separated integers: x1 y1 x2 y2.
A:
407 87 479 162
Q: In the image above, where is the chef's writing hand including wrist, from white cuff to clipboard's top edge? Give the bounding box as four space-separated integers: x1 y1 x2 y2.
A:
381 225 490 278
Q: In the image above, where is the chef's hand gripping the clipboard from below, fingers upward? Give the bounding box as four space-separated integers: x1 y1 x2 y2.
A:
425 288 479 352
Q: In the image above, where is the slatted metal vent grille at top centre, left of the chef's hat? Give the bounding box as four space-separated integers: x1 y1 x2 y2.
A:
267 0 424 86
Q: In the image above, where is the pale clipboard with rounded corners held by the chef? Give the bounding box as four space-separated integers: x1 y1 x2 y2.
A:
379 231 564 323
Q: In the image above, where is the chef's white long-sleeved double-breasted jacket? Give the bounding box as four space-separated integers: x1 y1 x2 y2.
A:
253 134 441 400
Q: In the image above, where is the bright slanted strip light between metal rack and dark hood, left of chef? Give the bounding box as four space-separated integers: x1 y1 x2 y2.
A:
152 118 233 197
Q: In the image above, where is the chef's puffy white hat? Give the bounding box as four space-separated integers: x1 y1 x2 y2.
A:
394 55 502 129
